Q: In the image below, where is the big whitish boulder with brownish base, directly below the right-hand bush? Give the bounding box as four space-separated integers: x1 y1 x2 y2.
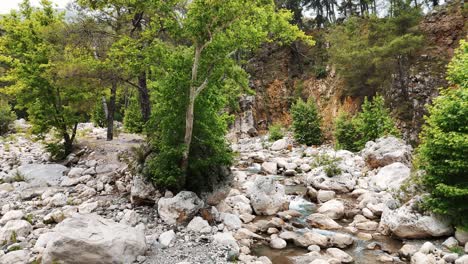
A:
362 136 413 168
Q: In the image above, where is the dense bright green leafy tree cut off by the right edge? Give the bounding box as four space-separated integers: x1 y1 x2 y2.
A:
417 41 468 229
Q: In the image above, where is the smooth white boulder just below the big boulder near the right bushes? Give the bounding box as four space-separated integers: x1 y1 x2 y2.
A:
370 162 411 191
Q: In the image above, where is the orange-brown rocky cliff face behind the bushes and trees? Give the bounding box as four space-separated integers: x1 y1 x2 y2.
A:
233 1 467 143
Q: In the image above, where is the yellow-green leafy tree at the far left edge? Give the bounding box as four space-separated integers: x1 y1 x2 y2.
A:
0 0 92 154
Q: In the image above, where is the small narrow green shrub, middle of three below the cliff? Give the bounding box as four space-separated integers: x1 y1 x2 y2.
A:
333 111 358 151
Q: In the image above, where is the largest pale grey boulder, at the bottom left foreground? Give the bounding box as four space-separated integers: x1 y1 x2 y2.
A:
36 214 146 264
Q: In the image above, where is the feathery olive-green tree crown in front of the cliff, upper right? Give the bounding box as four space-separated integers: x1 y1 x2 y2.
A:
327 3 424 96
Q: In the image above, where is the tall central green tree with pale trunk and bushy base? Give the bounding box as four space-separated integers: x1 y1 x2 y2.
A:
147 0 312 189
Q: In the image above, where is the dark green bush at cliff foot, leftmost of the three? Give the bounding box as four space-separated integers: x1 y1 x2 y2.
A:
291 98 323 145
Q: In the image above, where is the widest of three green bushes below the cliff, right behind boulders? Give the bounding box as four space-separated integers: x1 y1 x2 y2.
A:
352 95 400 150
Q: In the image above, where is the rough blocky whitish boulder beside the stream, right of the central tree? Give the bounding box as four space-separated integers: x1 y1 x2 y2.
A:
248 176 288 215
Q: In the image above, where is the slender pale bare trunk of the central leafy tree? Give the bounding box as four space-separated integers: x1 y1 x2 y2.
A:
181 46 202 175
